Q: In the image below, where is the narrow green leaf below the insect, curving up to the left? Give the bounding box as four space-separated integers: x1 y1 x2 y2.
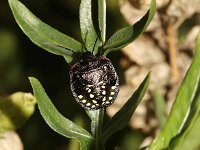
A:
29 77 92 147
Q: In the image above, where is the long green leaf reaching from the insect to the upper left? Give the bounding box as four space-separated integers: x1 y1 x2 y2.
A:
8 0 83 63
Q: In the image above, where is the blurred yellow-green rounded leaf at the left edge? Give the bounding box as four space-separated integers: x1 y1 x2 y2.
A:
0 92 36 134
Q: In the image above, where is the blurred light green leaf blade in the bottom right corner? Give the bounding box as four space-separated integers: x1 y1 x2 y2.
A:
169 82 200 150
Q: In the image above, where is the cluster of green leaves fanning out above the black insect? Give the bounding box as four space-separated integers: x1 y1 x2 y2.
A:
8 0 156 64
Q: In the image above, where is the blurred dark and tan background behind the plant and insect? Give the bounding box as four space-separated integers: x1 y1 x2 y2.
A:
0 0 200 150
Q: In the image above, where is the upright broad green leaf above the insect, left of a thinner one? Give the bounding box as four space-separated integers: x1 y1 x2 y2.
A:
79 0 102 54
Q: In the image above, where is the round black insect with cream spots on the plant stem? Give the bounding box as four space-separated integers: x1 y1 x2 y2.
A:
70 52 119 110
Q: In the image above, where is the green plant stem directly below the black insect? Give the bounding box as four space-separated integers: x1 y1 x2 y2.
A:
94 108 105 150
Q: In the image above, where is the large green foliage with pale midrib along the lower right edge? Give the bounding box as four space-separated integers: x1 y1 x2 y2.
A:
149 34 200 150
